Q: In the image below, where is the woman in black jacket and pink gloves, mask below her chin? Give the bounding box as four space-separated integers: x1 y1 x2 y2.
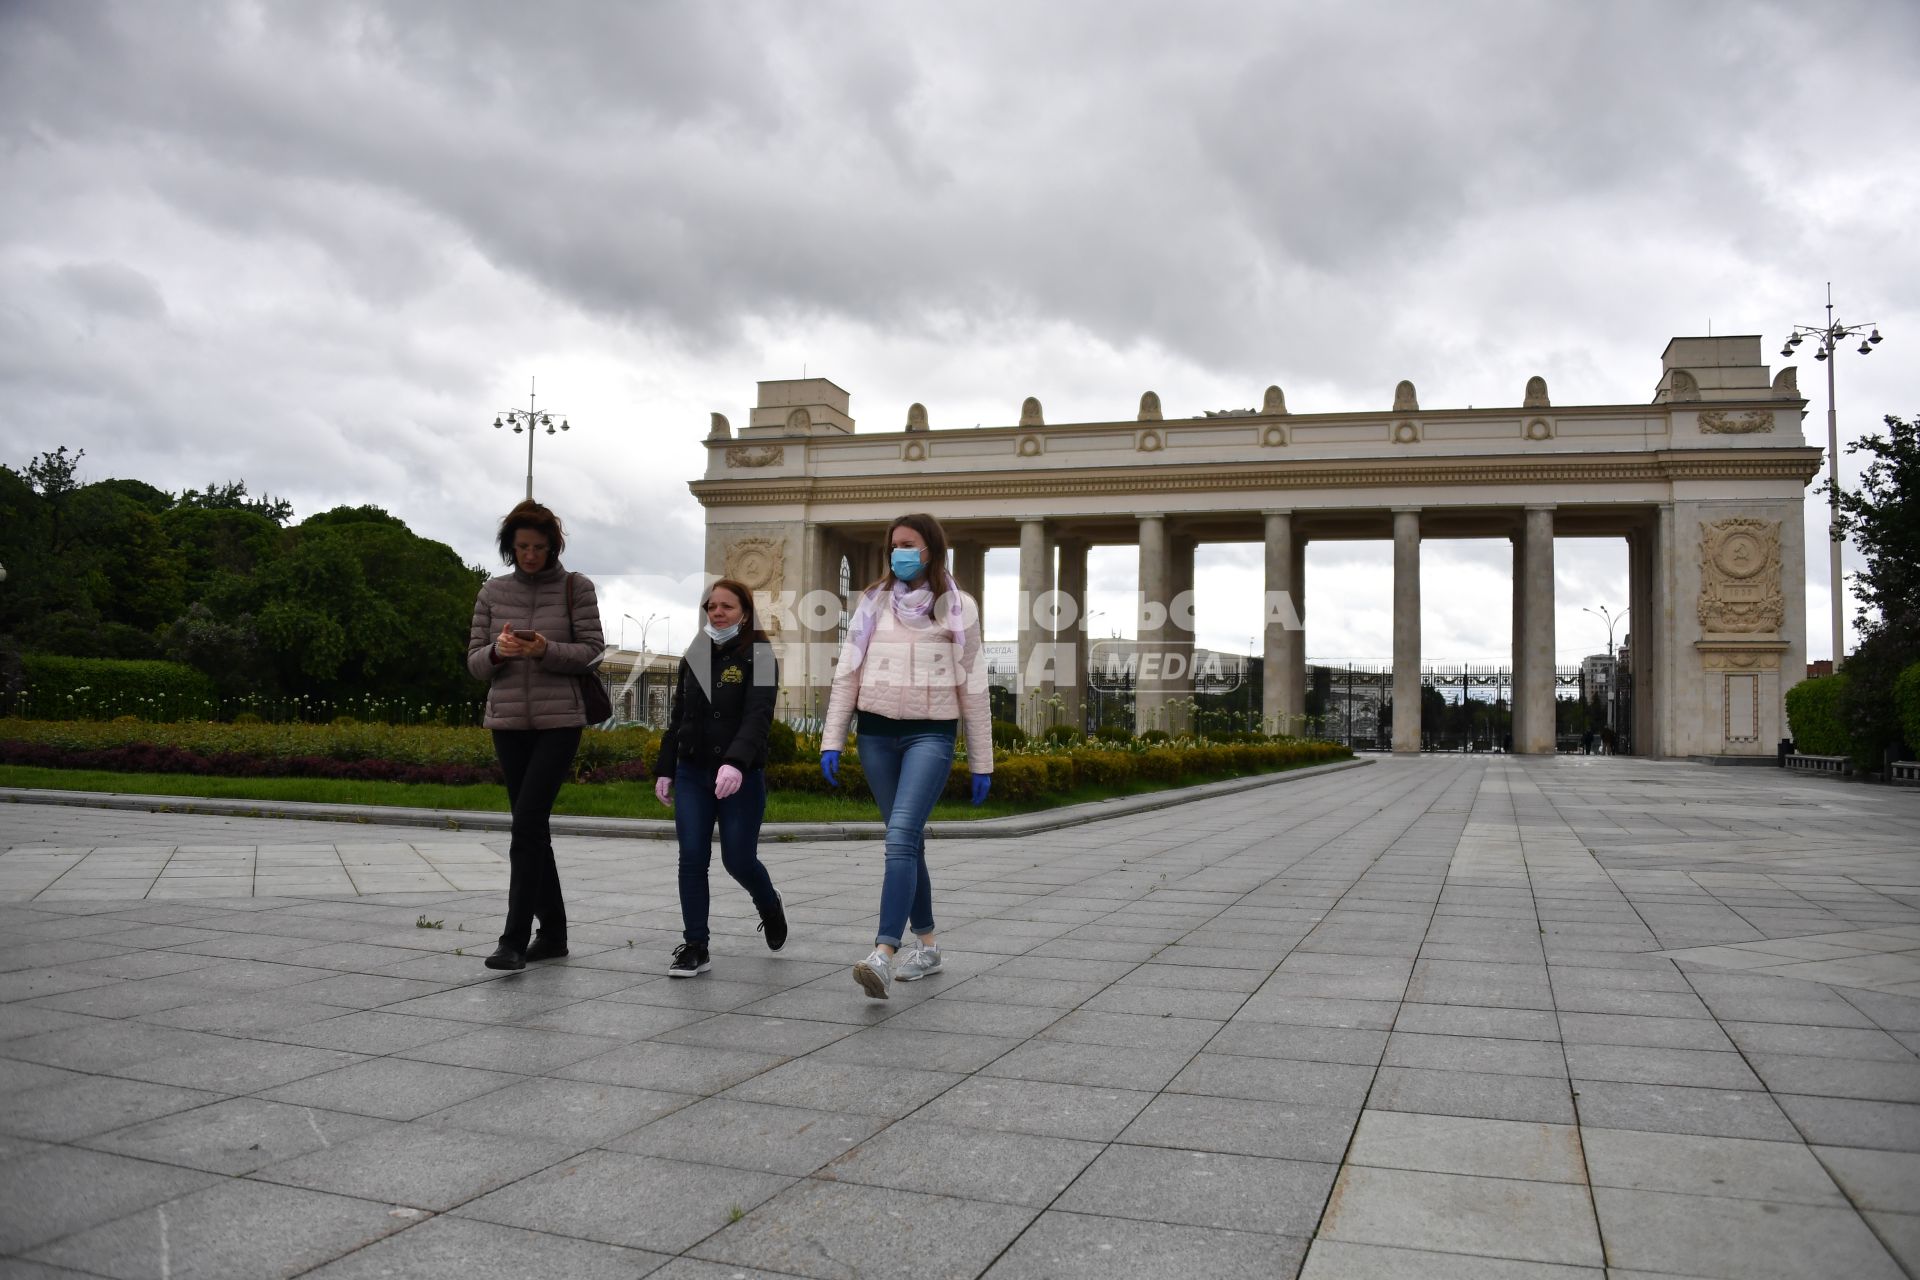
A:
653 578 787 979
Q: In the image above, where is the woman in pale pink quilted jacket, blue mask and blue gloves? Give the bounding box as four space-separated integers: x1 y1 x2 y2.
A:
820 514 993 1000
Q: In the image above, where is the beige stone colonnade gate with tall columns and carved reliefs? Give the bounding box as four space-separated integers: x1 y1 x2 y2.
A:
689 336 1822 756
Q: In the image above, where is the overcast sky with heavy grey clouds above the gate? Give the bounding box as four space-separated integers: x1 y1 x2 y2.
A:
0 0 1920 662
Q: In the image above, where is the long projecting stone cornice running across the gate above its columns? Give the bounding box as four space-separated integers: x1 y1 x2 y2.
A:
687 450 1822 507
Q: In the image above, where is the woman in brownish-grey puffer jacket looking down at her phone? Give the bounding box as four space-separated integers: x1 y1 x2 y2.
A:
467 501 605 969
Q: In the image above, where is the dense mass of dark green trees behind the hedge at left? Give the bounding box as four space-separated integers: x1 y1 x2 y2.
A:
0 447 486 706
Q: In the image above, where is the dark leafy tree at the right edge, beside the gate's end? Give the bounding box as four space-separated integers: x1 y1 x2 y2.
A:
1820 415 1920 770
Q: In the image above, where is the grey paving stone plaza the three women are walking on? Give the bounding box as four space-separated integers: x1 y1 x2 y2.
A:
0 756 1920 1280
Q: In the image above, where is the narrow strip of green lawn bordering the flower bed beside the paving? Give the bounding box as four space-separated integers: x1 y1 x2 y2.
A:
0 766 1336 821
